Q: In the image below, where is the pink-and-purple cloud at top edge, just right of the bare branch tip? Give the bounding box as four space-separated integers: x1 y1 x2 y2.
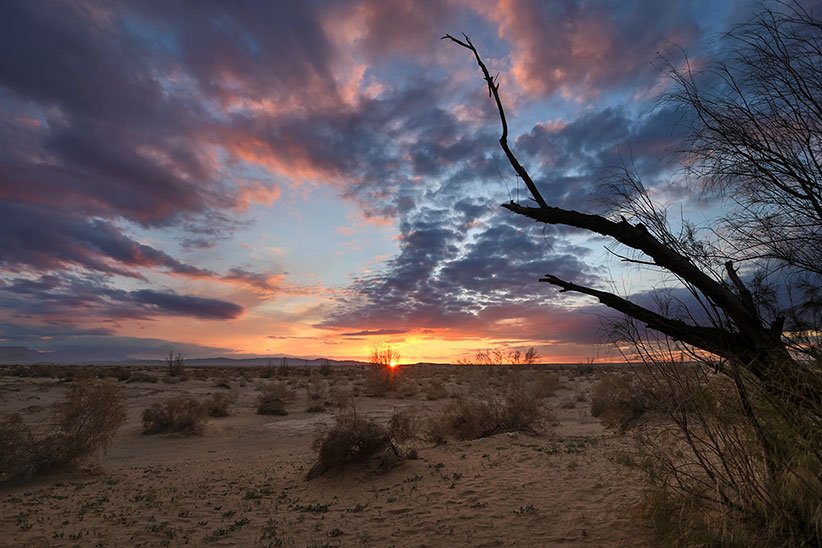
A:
479 0 700 99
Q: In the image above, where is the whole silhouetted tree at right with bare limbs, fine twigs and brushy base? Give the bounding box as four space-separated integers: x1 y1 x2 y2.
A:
443 4 822 544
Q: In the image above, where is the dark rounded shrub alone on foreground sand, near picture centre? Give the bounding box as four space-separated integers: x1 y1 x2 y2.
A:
307 407 398 479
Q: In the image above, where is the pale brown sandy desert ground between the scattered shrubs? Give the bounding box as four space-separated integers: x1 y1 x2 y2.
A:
0 366 651 547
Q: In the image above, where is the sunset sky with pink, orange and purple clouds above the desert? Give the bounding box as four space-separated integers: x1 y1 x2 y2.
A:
0 0 784 362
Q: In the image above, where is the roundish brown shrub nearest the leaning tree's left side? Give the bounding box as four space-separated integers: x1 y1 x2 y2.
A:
591 375 652 431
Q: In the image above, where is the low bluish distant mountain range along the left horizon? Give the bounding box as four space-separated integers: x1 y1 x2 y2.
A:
0 346 365 366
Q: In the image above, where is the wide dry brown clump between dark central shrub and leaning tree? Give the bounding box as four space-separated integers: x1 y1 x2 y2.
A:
428 373 544 443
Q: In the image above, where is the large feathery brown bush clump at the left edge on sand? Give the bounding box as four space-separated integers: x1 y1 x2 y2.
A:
0 380 126 483
